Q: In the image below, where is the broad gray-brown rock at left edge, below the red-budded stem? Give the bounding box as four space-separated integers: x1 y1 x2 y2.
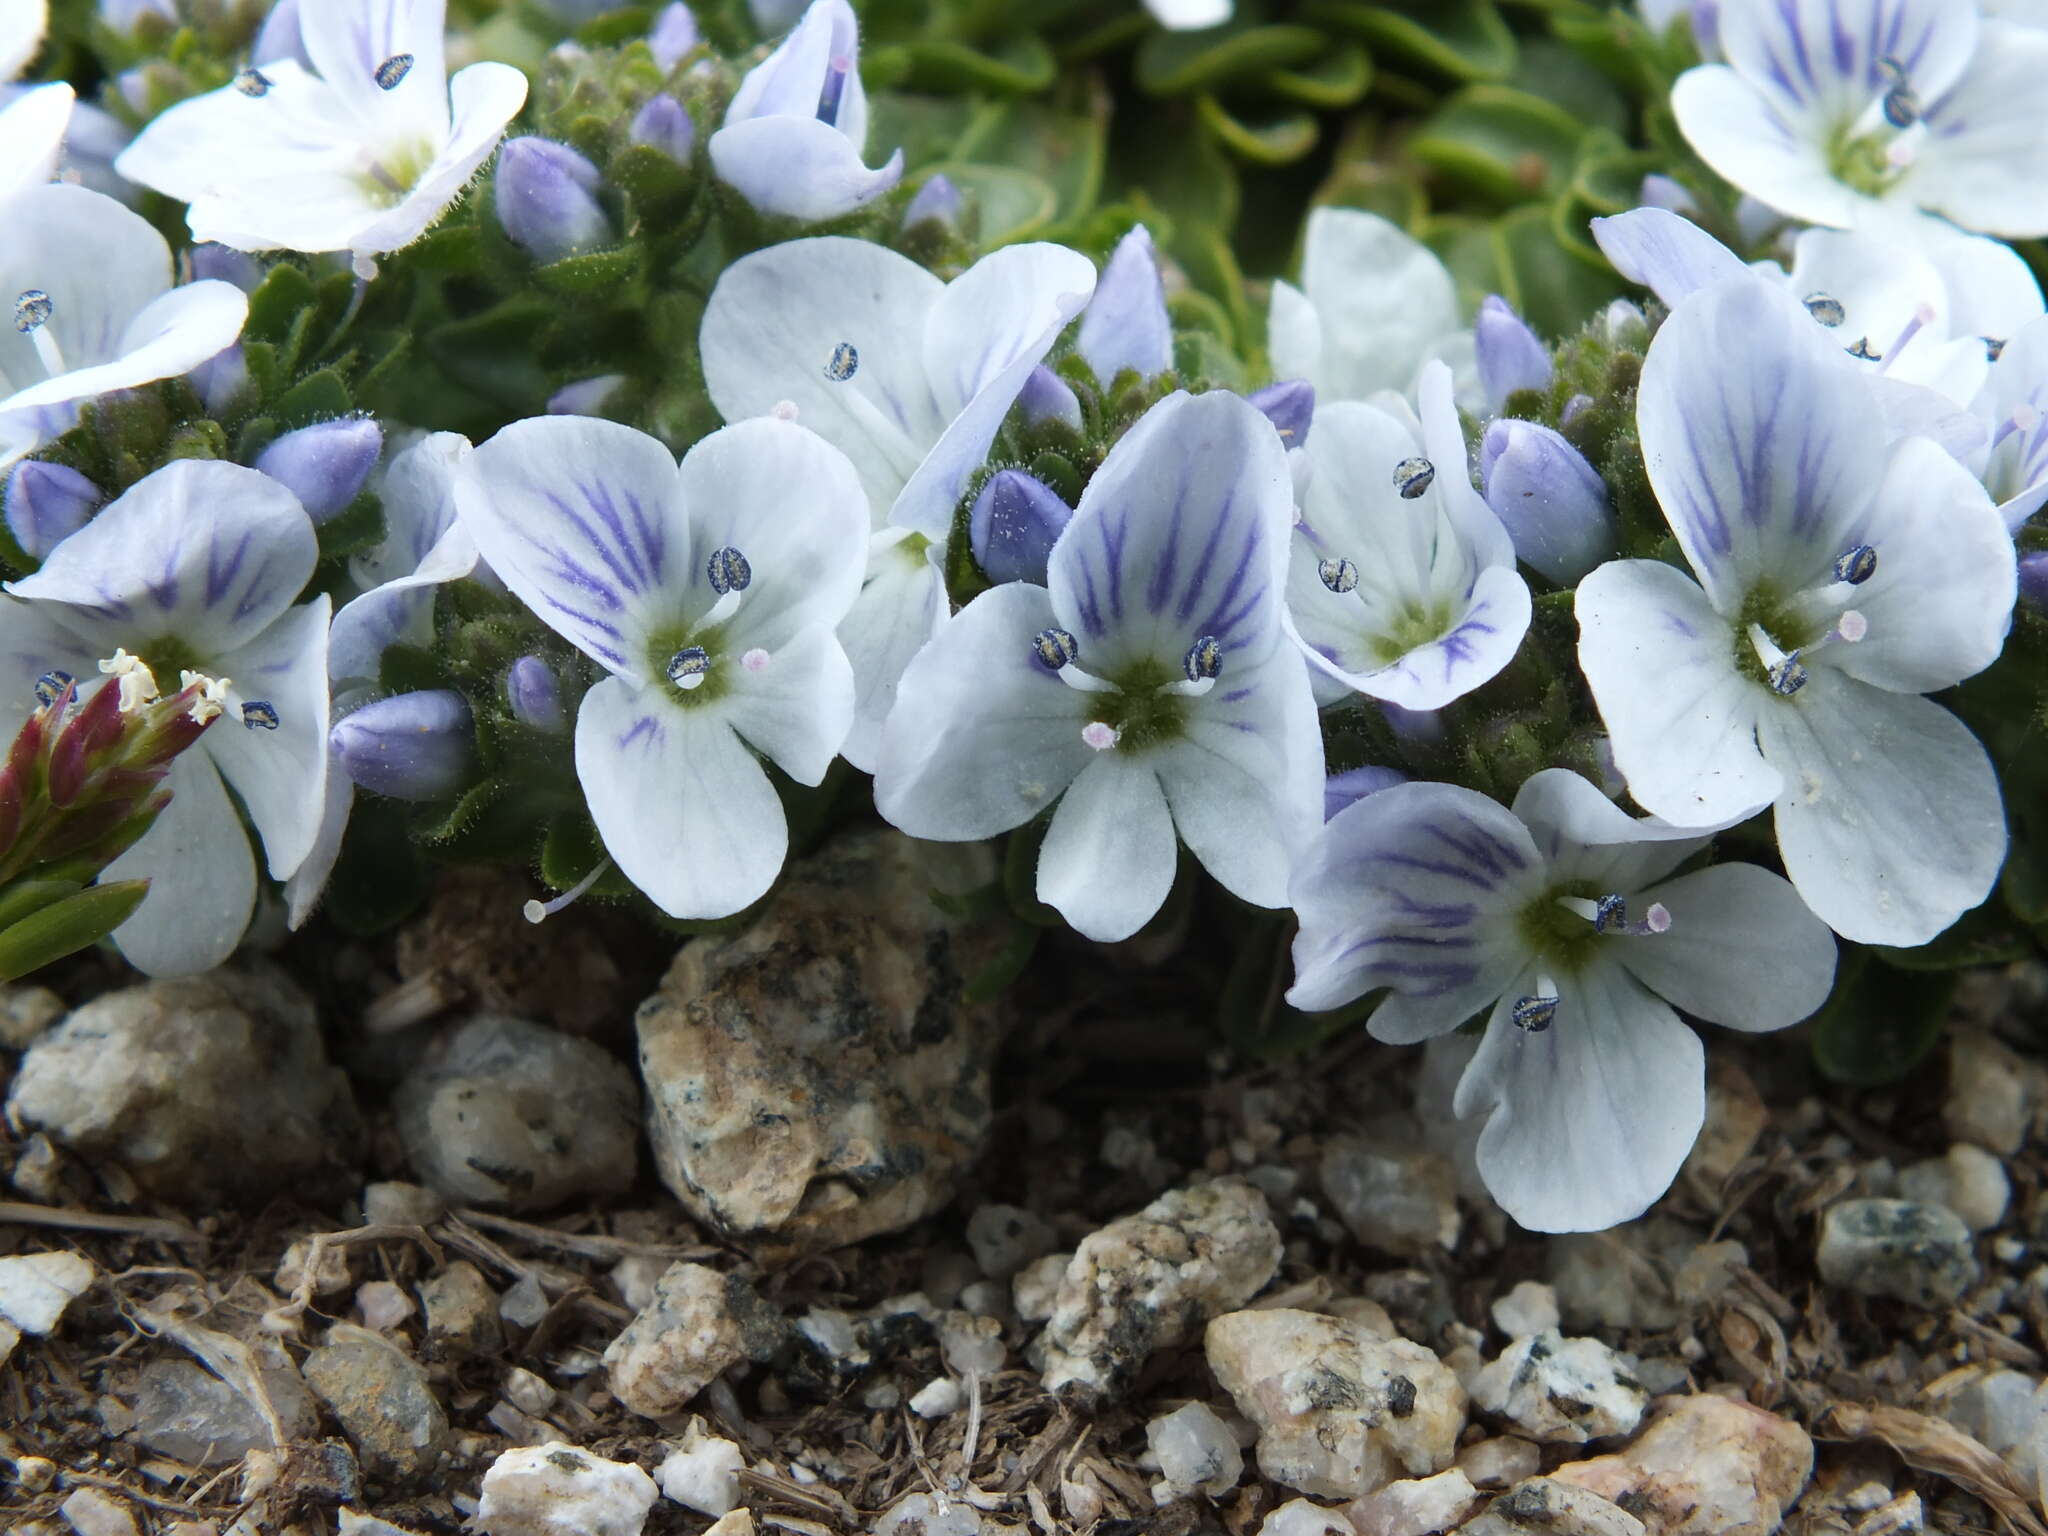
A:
8 965 362 1210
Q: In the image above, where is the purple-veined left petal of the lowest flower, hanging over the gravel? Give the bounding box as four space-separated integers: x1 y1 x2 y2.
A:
1288 784 1546 1028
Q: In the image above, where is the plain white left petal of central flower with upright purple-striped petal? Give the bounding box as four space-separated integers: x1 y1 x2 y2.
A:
874 582 1096 842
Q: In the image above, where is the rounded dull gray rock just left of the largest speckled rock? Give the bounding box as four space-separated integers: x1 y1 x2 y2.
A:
397 1014 639 1210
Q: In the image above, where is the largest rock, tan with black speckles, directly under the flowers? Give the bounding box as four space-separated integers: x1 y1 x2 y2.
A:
637 831 1001 1249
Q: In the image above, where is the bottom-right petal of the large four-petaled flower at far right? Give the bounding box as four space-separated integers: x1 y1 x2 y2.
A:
1757 670 2005 946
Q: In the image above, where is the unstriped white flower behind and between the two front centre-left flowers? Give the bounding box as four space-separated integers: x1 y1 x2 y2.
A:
698 236 1096 770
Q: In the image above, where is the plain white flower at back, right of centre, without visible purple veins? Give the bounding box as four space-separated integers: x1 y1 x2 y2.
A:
1266 209 1485 414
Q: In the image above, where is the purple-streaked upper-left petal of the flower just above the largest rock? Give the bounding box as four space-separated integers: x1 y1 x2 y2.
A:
455 416 696 680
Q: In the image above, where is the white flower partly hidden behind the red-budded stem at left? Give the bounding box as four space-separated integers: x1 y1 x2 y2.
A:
0 459 328 975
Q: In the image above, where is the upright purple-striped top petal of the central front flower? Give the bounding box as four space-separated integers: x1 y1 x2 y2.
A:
1051 391 1294 680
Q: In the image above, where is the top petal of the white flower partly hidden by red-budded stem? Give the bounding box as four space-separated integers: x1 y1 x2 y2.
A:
8 459 319 655
